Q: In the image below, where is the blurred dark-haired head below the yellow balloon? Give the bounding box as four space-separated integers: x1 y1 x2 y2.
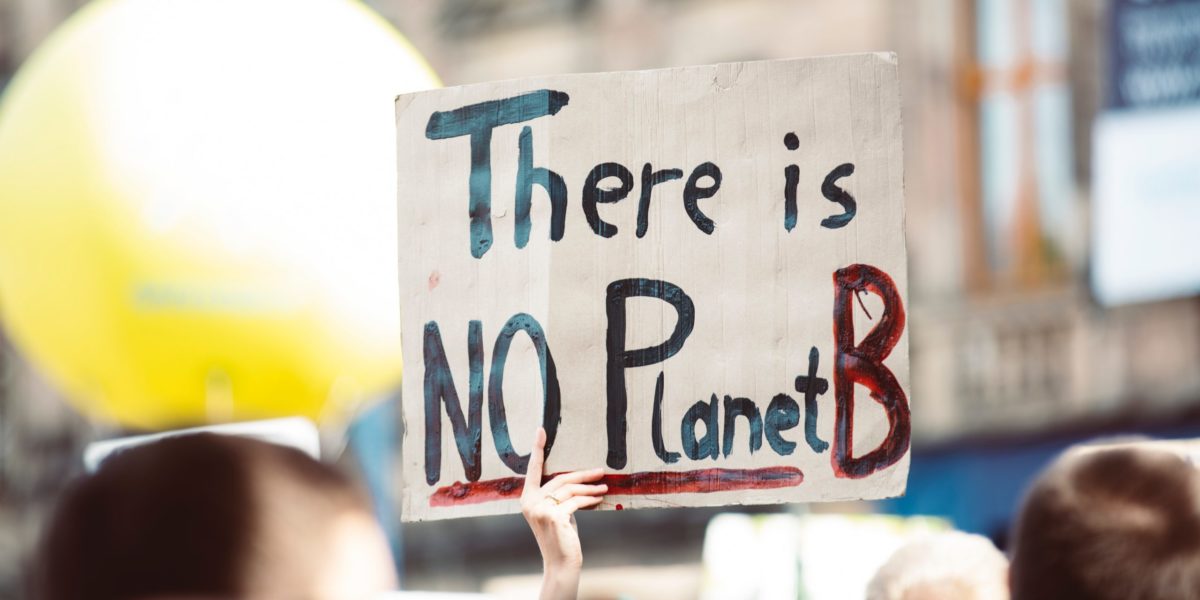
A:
34 433 394 600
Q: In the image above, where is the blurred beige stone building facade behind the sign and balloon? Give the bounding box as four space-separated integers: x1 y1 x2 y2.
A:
0 0 1200 593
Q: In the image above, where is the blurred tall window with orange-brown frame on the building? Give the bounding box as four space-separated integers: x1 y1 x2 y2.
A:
964 0 1079 288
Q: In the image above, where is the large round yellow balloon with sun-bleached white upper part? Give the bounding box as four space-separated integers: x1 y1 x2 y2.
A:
0 0 439 428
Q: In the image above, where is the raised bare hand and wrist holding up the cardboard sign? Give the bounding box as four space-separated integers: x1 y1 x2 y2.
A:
521 427 608 600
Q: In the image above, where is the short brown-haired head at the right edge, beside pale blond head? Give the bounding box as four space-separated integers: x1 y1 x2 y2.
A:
1012 446 1200 600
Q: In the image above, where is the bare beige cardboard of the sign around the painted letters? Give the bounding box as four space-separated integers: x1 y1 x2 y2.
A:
396 54 908 521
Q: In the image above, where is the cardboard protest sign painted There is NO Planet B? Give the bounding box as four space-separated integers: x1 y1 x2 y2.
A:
396 54 910 520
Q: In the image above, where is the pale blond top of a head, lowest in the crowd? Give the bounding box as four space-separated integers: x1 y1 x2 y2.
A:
866 532 1008 600
